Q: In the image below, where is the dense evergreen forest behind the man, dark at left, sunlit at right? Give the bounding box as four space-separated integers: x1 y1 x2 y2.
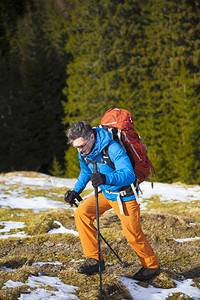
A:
0 0 200 184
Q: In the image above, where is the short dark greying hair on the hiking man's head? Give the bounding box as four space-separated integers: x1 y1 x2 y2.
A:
67 121 93 144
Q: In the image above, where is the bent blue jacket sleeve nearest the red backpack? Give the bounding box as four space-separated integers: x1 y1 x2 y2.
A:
106 141 135 186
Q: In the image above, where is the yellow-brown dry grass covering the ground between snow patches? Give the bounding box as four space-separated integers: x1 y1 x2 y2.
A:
0 172 200 300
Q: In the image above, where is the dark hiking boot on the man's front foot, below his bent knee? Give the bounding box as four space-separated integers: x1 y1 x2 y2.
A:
77 258 105 275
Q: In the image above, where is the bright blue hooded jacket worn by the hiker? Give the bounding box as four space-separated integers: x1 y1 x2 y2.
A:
74 127 135 201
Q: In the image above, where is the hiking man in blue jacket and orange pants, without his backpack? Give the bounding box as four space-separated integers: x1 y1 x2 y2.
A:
65 121 160 280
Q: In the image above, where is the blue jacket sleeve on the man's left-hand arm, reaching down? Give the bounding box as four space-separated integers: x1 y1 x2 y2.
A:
74 154 92 193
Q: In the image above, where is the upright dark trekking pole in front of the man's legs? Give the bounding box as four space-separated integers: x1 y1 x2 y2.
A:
93 163 103 300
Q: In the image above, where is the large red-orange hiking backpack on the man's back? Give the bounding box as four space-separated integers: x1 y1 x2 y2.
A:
100 108 156 183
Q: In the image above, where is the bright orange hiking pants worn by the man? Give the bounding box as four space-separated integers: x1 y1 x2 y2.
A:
74 192 159 268
